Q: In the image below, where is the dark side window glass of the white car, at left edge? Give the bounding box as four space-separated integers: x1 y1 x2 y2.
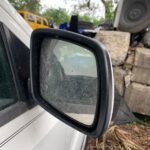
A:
0 35 17 111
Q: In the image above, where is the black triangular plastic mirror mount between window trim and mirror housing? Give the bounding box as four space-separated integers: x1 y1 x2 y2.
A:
3 24 36 108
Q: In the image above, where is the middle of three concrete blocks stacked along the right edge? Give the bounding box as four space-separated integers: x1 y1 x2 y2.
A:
131 67 150 85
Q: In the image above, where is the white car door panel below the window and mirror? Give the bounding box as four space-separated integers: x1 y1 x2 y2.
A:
0 106 86 150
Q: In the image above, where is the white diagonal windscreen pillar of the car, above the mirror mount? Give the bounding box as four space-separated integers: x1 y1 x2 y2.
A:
0 0 32 47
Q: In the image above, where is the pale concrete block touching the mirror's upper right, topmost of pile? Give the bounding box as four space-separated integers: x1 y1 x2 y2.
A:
95 31 130 66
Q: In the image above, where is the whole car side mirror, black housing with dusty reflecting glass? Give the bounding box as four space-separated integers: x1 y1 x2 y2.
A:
30 29 114 137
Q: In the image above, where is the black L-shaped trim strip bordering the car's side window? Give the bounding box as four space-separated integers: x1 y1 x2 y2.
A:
0 22 29 127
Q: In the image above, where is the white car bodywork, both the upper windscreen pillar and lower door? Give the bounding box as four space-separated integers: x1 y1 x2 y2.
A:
0 0 86 150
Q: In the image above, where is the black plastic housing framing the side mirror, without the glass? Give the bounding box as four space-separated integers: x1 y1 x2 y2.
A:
30 29 114 137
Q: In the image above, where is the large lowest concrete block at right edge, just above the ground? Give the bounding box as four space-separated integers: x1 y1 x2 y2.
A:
125 83 150 115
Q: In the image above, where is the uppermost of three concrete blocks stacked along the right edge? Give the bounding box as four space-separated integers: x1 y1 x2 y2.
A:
135 48 150 69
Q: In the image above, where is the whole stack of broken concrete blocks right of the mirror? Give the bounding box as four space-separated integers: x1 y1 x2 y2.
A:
96 31 150 116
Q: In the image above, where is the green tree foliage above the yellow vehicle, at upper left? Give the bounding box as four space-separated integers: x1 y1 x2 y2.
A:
9 0 41 14
